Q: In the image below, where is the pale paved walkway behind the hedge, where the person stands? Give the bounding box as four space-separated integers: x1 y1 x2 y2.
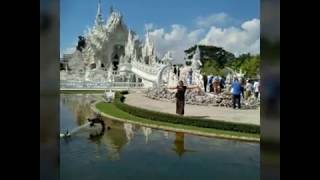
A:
125 93 260 125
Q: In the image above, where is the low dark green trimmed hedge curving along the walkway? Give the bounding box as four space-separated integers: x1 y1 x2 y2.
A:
113 92 260 134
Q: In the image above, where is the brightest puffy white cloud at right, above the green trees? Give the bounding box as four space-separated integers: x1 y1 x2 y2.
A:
199 19 260 55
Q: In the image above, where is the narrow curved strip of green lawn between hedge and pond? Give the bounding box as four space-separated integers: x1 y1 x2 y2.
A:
96 102 260 138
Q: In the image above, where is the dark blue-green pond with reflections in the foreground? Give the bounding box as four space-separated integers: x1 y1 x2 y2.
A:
60 94 260 180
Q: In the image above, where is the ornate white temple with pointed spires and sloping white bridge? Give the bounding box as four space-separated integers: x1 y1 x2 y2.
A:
60 1 173 88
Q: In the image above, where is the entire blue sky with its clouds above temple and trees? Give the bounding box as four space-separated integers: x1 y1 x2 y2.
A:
60 0 260 61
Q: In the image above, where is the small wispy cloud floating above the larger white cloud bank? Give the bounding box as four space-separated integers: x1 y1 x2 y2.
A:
196 12 234 28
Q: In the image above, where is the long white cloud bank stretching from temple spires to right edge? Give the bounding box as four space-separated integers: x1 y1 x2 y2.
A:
150 19 260 63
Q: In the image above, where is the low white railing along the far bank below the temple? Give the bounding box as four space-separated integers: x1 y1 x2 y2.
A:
60 81 143 89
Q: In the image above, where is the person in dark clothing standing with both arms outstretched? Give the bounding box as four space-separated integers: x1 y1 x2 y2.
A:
168 81 200 116
